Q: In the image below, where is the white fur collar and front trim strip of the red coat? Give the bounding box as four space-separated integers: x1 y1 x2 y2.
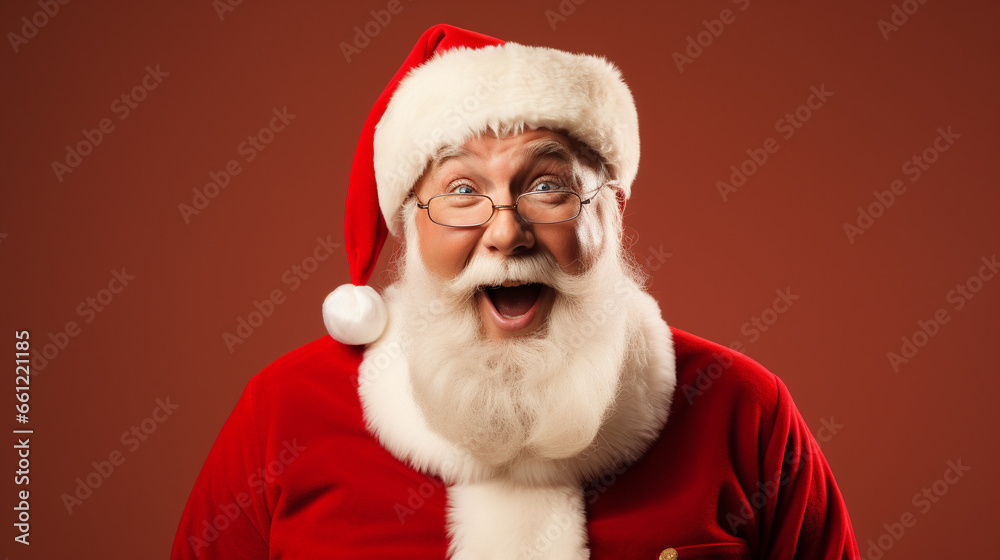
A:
358 286 677 560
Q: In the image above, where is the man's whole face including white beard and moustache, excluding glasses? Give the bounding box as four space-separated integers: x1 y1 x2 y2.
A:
383 130 648 465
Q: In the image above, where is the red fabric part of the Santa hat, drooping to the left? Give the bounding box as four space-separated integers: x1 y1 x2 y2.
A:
344 24 504 286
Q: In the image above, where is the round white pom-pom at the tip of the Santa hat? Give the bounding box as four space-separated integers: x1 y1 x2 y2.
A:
323 284 389 345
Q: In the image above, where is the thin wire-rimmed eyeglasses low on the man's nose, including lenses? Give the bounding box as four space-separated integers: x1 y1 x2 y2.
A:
417 185 604 227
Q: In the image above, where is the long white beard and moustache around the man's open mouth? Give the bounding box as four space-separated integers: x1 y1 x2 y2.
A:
386 238 639 466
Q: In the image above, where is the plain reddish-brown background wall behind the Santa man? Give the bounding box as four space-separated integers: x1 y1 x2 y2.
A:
0 0 1000 559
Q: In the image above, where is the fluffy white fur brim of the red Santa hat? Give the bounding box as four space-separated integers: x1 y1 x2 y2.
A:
374 43 639 235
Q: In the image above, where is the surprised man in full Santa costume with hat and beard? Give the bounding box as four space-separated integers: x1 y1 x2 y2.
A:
173 26 858 559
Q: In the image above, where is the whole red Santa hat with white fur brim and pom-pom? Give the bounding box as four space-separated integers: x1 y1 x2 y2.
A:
323 25 639 345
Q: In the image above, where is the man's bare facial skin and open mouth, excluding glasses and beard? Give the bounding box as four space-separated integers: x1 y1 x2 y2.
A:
415 129 590 339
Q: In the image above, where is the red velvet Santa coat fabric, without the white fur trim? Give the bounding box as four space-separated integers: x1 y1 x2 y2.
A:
171 329 859 560
